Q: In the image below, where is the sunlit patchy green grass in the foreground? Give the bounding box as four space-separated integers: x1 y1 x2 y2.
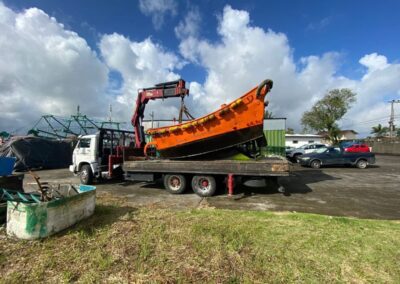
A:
0 198 400 283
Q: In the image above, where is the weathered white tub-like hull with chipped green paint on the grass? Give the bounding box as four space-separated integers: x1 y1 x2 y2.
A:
7 185 96 240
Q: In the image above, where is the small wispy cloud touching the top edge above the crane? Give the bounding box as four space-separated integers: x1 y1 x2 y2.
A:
139 0 178 30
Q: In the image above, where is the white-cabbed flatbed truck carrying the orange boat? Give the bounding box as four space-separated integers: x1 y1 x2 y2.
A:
70 129 289 197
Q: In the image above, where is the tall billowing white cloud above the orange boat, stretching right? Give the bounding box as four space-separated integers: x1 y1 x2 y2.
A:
179 6 400 136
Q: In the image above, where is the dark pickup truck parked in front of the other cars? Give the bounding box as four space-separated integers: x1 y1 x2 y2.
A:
298 147 375 169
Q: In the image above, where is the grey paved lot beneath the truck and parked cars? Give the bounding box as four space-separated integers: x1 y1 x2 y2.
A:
24 155 400 219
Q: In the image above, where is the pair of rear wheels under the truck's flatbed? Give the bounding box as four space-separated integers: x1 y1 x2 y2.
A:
164 174 217 197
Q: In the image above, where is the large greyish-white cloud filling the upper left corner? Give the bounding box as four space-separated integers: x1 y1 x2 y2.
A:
0 2 108 130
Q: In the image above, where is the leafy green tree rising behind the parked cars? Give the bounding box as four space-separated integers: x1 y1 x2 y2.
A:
301 89 357 144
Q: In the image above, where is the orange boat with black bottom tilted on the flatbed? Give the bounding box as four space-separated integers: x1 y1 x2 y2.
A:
145 80 272 158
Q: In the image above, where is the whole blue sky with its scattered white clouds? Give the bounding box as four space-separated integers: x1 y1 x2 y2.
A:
0 0 400 136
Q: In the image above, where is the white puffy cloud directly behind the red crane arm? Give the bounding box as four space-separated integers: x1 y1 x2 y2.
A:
100 33 183 118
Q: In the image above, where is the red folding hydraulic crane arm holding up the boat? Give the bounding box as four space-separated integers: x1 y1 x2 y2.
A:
131 79 189 148
